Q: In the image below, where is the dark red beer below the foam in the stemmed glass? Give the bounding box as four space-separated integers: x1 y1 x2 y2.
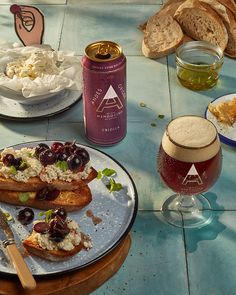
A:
159 145 221 195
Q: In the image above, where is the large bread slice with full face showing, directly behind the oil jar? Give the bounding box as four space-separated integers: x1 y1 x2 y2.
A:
174 0 228 51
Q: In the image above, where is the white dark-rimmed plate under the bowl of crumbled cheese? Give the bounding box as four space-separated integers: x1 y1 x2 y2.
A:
0 90 82 120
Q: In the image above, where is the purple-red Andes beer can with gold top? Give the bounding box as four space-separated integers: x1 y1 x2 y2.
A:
82 41 127 145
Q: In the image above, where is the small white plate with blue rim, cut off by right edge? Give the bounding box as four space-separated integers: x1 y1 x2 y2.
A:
205 93 236 147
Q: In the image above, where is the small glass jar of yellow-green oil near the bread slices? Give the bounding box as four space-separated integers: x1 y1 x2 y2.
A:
176 41 224 90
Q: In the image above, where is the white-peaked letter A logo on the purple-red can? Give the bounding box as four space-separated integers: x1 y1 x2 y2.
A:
96 85 123 113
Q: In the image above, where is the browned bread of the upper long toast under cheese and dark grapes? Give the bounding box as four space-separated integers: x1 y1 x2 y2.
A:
0 168 97 192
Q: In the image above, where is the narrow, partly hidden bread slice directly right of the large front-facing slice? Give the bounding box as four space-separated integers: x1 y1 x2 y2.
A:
200 0 236 57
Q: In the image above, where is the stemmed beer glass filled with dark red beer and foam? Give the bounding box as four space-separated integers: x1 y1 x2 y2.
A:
158 116 222 228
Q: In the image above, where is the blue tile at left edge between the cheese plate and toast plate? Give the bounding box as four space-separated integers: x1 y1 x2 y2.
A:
0 120 48 148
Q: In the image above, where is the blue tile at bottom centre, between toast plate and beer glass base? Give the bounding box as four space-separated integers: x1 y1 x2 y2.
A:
92 212 187 295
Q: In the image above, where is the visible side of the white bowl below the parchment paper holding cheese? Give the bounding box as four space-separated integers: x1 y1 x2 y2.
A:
0 86 66 105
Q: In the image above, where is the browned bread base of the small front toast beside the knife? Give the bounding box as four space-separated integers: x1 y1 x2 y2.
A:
23 238 83 261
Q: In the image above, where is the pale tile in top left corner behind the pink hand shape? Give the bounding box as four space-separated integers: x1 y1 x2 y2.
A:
0 3 65 49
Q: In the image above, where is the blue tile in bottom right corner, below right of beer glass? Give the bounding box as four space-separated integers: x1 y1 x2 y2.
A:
185 212 236 295
